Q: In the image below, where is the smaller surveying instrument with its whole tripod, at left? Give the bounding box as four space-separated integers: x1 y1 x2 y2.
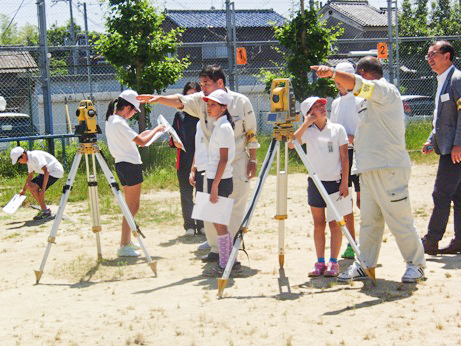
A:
35 100 157 284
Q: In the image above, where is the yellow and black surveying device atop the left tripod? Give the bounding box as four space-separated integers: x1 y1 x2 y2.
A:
75 100 101 143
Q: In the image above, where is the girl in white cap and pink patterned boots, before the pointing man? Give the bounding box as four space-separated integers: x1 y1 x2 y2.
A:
203 89 235 276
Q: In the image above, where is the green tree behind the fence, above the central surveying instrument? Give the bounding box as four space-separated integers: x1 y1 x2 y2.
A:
261 9 343 101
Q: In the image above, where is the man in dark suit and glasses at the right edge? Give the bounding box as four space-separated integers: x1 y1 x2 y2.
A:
422 41 461 255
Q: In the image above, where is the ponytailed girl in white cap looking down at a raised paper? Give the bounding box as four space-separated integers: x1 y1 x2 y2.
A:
106 90 165 257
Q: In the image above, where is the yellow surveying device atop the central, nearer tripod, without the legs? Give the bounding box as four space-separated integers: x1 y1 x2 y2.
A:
267 78 300 141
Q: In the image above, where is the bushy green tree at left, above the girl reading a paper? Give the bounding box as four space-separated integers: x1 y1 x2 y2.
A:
96 0 189 131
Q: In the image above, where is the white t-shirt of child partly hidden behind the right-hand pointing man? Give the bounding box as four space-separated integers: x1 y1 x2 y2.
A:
330 92 363 147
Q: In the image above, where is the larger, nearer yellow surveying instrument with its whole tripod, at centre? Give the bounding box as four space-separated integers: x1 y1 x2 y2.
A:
218 78 375 298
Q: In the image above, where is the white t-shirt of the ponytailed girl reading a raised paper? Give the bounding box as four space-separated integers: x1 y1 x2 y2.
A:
106 114 142 165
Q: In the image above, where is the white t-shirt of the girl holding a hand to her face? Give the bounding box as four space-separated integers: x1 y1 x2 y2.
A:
301 121 349 181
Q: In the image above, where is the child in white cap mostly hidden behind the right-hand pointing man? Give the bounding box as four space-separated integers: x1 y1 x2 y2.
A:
330 62 363 259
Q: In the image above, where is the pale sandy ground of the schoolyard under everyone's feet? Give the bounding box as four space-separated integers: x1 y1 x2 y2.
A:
0 166 461 345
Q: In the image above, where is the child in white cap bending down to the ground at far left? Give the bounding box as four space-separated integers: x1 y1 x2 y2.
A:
10 147 64 220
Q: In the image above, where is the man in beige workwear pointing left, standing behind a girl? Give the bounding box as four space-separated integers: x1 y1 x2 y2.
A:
138 65 259 262
